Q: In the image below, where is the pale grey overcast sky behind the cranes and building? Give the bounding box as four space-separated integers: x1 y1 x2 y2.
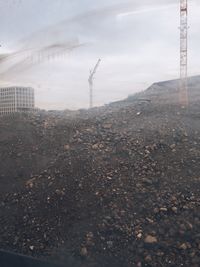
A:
0 0 200 109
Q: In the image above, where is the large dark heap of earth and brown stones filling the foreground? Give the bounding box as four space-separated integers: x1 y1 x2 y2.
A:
0 85 200 267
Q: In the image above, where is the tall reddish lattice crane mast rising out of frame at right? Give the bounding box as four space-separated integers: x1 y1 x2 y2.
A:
180 0 188 106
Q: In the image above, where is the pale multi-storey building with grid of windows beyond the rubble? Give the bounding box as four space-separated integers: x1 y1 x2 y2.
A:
0 87 35 115
